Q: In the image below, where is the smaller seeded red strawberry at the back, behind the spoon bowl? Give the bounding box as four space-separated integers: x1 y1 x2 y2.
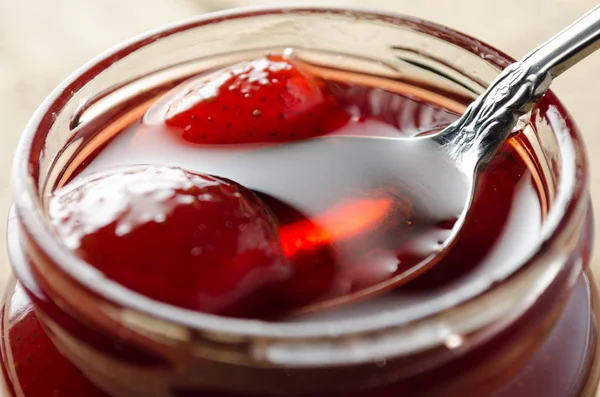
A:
145 55 350 144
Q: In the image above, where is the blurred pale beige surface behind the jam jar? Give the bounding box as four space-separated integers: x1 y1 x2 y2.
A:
0 0 600 392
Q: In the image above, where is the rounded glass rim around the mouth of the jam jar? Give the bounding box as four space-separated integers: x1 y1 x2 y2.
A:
12 6 587 360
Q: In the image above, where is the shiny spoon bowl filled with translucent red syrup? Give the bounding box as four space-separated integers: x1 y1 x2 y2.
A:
219 136 472 312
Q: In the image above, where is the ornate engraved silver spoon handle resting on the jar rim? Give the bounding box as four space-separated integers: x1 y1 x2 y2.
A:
434 5 600 173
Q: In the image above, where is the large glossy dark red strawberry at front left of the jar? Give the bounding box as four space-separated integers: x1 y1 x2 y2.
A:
49 166 293 317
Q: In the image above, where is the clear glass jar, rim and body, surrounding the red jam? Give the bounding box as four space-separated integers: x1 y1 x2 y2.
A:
1 8 600 397
